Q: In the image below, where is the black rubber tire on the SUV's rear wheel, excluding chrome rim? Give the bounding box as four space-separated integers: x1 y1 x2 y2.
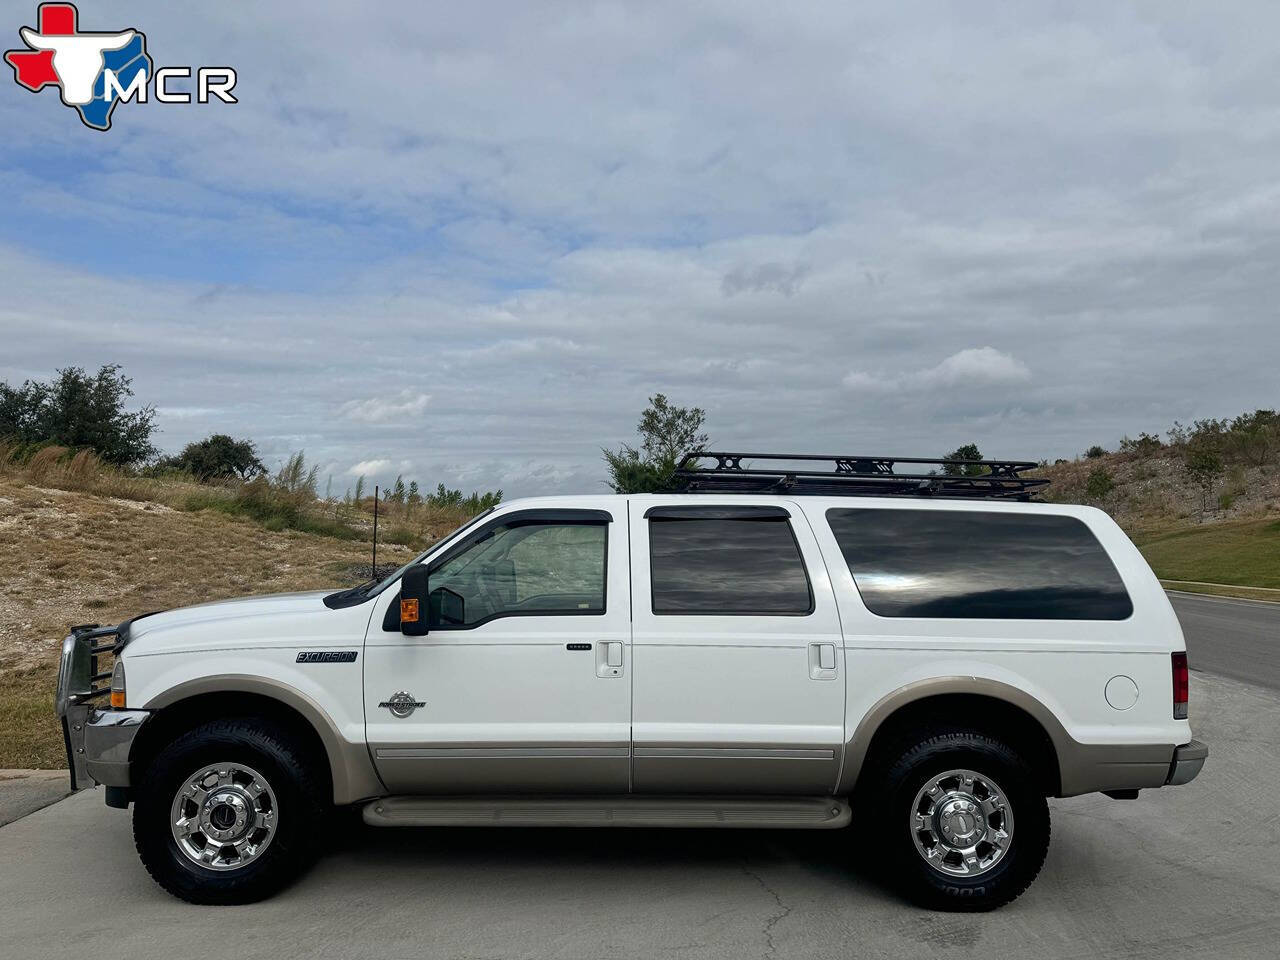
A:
860 728 1050 911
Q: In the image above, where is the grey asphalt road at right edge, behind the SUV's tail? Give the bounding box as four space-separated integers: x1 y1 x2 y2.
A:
1169 591 1280 691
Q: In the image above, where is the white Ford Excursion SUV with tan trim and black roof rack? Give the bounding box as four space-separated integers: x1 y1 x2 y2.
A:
58 454 1207 909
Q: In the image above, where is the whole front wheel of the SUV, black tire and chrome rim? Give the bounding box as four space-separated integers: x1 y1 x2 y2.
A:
133 719 326 904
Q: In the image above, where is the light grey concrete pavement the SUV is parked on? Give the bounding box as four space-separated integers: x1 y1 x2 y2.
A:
0 673 1280 960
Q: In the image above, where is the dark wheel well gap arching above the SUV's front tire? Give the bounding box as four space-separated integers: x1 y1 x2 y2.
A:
129 692 333 799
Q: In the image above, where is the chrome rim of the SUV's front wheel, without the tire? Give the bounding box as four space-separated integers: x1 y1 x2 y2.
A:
169 763 276 870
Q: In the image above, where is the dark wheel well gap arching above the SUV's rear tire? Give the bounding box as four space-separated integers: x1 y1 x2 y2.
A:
858 694 1061 796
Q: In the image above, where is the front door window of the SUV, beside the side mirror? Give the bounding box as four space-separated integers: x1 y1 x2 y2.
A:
429 521 607 627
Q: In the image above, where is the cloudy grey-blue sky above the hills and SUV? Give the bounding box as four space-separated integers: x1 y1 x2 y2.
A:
0 0 1280 494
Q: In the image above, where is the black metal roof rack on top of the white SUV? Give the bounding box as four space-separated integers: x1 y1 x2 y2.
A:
672 451 1048 500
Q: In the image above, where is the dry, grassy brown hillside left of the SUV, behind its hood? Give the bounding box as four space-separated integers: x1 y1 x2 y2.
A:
0 471 481 768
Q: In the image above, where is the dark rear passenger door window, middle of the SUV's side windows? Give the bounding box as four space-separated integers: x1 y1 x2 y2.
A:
649 517 813 614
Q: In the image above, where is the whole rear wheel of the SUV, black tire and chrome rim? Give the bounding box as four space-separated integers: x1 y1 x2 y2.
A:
872 731 1050 910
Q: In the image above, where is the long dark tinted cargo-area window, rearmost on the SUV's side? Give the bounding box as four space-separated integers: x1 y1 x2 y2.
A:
827 509 1133 620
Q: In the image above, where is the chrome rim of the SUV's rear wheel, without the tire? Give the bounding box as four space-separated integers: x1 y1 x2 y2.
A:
910 771 1014 877
